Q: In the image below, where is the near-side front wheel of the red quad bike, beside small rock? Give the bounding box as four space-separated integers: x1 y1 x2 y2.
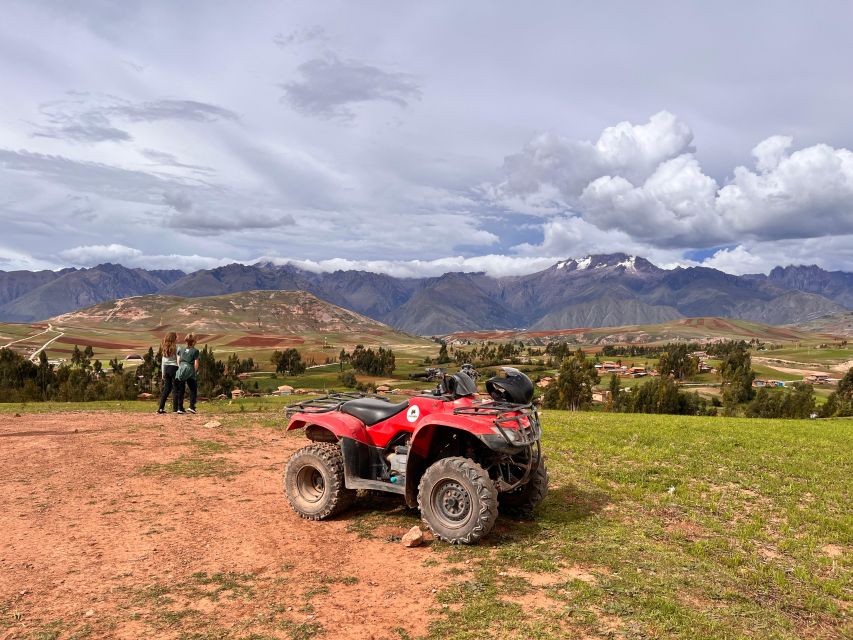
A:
418 457 498 544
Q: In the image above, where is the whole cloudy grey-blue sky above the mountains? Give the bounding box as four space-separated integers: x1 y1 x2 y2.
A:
0 0 853 274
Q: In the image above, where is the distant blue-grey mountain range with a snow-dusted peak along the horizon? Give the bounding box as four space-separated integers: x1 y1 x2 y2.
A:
0 253 853 335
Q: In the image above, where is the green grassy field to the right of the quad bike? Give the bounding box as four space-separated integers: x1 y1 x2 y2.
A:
422 411 853 639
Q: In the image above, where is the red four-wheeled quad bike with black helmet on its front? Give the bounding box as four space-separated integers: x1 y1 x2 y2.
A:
284 367 548 544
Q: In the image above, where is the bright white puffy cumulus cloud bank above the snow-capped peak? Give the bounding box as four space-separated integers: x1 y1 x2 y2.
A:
492 111 853 252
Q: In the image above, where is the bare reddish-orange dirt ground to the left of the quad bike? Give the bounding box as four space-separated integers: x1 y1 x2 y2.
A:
0 413 448 640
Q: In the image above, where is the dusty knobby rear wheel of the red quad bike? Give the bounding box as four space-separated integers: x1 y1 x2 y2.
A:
284 442 356 520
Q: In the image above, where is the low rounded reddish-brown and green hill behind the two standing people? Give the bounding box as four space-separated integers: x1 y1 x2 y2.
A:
0 291 437 367
